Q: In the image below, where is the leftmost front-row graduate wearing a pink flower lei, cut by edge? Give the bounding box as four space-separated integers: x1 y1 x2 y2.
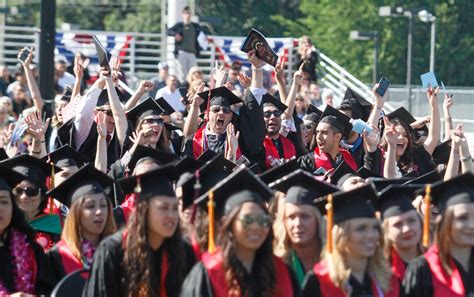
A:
0 166 52 296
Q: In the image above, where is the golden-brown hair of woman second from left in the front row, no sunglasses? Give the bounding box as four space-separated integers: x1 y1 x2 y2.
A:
61 196 117 259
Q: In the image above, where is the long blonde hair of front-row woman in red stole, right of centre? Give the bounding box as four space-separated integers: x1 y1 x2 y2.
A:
324 221 391 293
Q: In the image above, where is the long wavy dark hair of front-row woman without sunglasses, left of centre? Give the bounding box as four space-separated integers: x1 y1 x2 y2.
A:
122 200 186 296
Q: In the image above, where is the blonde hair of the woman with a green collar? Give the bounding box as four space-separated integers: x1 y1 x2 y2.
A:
273 199 326 262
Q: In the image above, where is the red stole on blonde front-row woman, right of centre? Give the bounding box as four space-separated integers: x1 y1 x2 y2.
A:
313 260 399 297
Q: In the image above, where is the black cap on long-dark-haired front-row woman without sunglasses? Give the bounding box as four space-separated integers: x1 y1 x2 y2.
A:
119 164 177 201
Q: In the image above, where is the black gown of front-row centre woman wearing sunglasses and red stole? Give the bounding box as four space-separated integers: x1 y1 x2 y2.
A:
180 262 300 297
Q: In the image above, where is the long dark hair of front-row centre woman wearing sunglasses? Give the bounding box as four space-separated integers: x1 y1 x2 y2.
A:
219 201 276 296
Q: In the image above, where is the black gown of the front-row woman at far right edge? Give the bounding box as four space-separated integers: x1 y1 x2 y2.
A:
400 249 474 297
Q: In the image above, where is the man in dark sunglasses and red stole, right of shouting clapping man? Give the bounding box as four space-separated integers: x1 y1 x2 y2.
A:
262 93 296 169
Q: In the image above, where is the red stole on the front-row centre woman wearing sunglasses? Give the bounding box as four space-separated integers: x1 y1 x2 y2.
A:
202 253 293 297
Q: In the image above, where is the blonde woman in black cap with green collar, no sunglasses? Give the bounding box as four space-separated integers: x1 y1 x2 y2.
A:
270 169 338 285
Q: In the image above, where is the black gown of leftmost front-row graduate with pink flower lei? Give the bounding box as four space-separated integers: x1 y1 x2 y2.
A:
0 228 55 295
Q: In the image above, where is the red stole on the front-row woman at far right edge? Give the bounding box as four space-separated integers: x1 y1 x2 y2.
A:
424 245 465 297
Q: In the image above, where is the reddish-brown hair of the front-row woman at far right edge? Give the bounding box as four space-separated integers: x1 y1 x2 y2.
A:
434 206 454 275
